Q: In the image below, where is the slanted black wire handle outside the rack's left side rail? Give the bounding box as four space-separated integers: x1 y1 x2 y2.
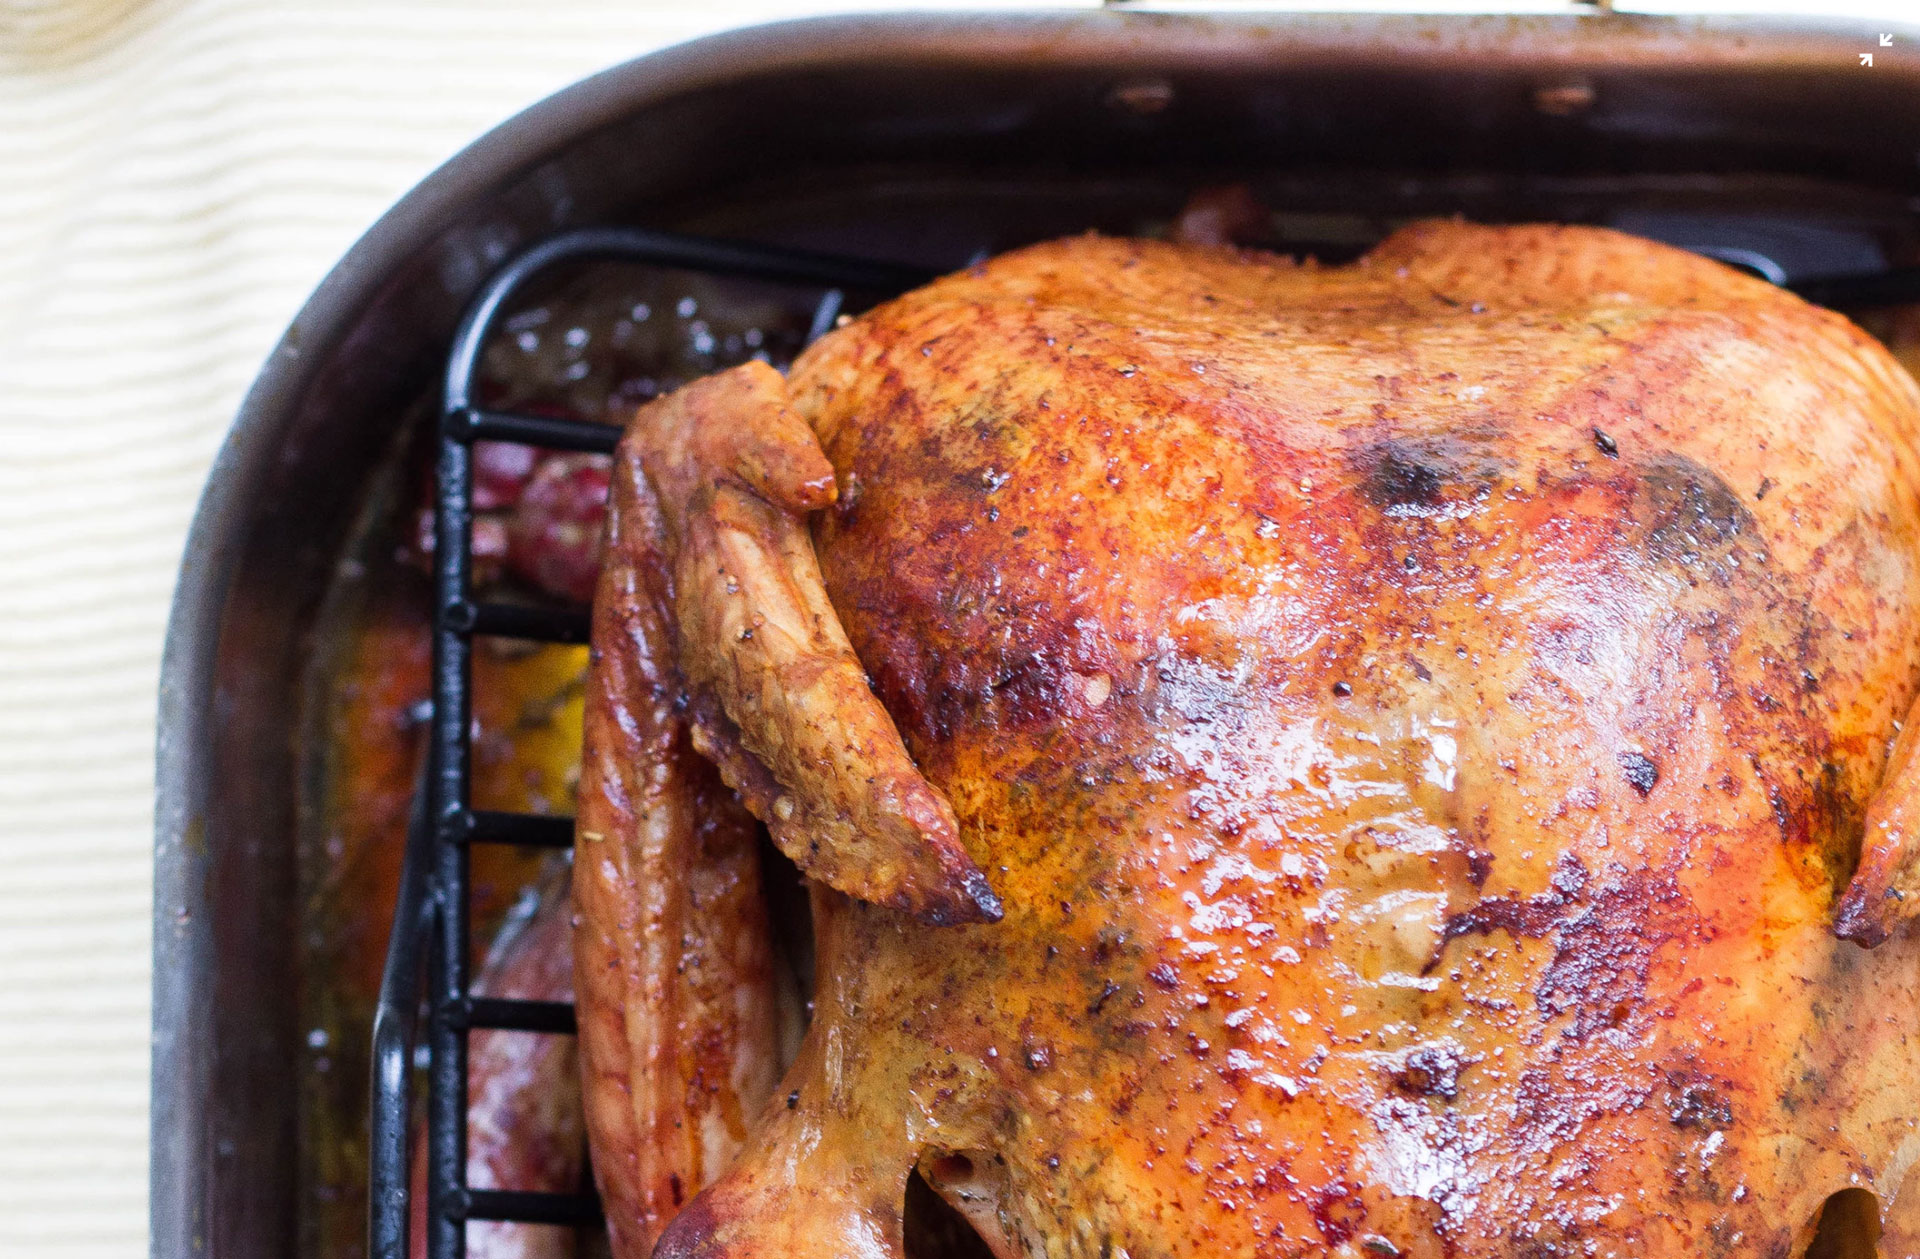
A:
367 758 434 1259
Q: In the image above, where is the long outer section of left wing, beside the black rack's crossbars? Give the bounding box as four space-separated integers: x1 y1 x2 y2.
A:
574 427 799 1255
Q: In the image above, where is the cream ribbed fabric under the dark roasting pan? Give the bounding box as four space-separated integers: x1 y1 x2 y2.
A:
0 0 1920 1255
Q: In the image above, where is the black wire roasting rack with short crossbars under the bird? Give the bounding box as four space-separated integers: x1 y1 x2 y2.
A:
369 228 1920 1259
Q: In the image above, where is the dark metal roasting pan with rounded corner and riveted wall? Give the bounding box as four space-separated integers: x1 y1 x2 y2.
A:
152 10 1920 1257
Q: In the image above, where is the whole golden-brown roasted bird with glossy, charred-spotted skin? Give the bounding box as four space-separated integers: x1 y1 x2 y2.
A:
574 223 1920 1259
